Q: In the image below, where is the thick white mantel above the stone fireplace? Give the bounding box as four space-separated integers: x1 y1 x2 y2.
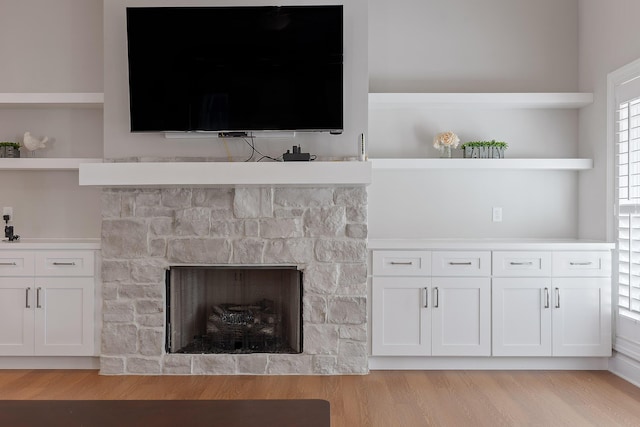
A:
79 161 371 187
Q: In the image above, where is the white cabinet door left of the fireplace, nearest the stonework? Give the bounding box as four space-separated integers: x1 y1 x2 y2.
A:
35 277 94 356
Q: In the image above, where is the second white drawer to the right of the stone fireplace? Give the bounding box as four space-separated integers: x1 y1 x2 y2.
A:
431 251 491 276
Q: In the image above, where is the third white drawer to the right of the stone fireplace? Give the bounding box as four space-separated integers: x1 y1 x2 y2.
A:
492 251 551 277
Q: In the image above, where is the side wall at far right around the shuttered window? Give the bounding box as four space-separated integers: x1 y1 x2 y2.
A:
579 0 640 239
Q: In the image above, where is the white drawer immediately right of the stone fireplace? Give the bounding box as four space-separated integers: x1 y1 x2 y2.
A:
372 251 431 276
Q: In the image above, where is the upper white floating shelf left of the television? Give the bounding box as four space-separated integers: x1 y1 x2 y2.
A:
0 92 104 108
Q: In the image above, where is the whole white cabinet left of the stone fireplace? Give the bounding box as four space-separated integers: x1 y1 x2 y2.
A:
0 244 96 356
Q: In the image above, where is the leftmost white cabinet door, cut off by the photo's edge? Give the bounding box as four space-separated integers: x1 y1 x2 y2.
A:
0 277 34 356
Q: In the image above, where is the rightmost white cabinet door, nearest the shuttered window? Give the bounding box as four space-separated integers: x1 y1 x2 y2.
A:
553 278 611 356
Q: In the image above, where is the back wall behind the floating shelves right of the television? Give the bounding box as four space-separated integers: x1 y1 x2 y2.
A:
369 0 578 238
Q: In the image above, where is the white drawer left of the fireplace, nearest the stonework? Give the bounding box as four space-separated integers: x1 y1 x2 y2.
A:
36 251 94 276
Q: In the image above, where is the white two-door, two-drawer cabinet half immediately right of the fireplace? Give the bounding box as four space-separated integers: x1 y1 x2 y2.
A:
372 251 491 356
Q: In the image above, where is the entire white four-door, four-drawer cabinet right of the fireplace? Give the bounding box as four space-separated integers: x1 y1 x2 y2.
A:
371 244 611 357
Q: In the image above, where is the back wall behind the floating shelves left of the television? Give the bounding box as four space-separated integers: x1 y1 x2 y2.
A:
0 0 102 238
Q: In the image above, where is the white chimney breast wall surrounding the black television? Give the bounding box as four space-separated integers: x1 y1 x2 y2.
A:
104 0 368 159
